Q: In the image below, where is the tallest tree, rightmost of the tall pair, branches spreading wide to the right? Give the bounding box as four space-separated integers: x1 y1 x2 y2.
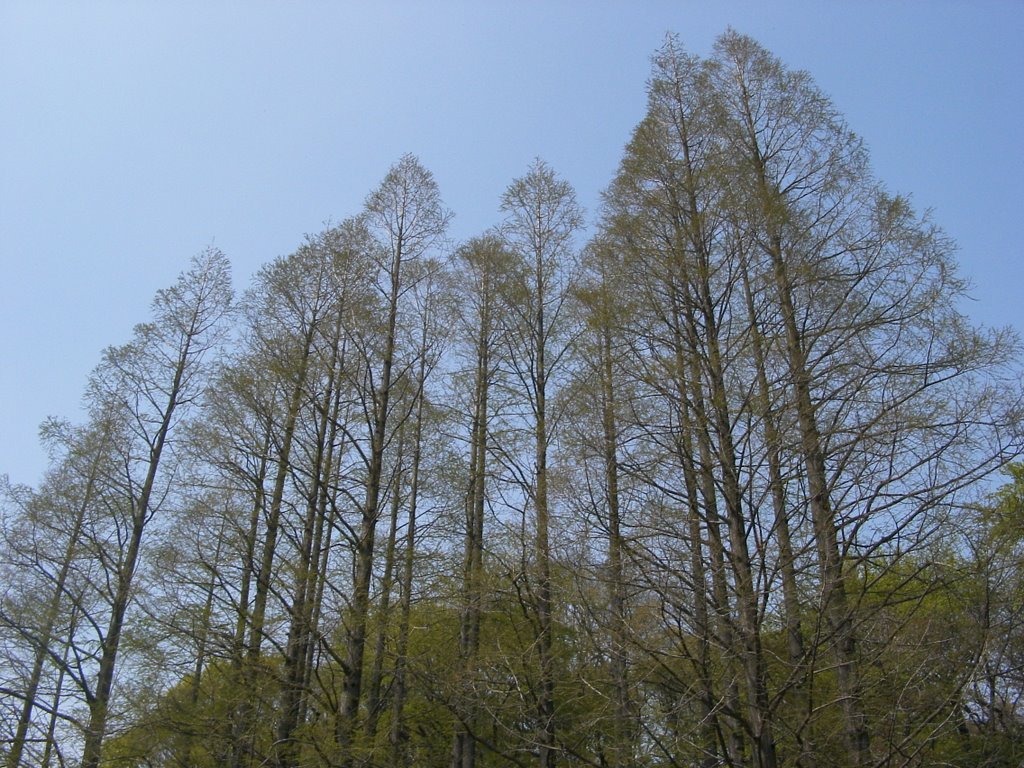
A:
711 33 1009 765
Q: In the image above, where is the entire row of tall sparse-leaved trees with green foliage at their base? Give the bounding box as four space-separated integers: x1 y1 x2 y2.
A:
0 32 1024 768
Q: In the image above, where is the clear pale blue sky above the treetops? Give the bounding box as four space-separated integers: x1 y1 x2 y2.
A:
0 0 1024 483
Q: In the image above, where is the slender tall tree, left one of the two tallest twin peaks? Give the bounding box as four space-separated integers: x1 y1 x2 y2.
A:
608 41 777 766
